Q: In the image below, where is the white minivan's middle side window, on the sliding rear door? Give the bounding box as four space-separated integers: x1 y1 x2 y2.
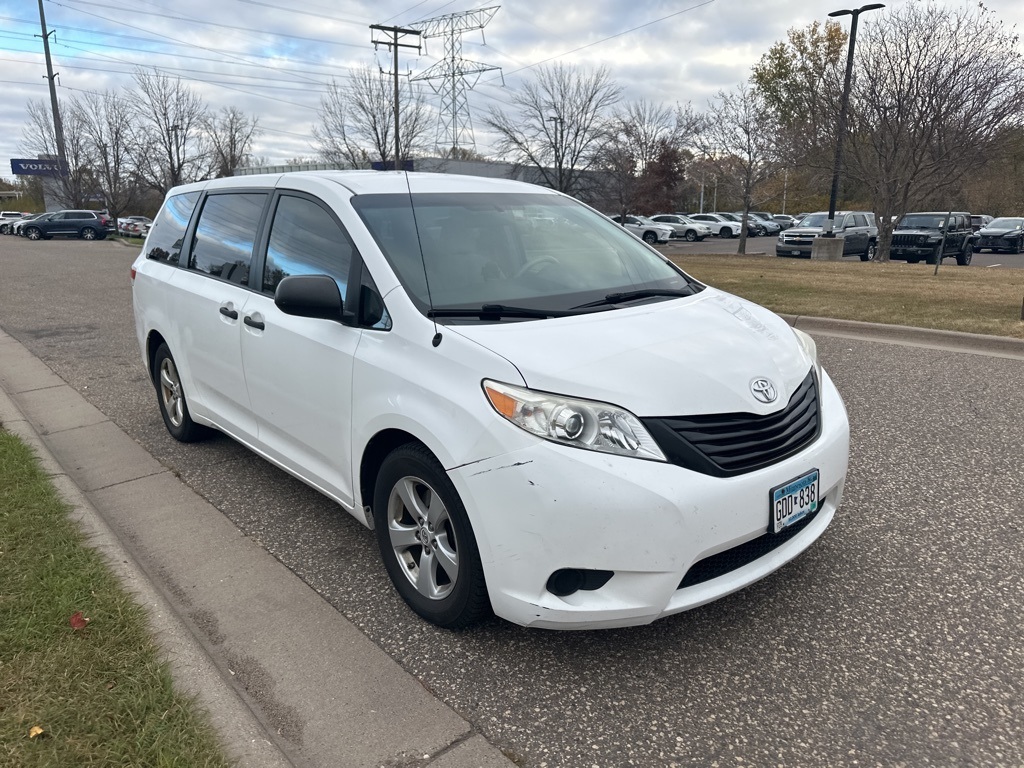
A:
188 193 266 286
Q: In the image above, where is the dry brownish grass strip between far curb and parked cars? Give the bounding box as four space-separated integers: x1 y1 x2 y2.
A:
671 254 1024 339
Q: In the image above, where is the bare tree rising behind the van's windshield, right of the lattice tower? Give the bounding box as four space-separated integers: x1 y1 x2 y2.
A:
483 63 622 195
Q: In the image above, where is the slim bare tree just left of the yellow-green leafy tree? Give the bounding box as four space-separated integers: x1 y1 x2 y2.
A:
696 83 779 253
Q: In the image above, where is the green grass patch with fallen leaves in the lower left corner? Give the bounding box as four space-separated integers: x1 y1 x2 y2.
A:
0 429 230 767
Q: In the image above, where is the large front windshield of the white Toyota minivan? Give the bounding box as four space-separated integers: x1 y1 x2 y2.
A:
352 193 700 311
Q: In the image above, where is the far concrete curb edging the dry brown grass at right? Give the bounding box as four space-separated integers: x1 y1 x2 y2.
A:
779 314 1024 358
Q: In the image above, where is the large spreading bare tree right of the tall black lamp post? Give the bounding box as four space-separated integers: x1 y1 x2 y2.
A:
847 3 1024 260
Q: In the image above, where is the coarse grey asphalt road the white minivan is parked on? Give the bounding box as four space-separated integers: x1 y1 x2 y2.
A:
0 238 1024 768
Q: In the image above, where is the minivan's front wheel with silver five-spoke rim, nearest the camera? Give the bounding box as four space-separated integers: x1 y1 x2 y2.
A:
374 442 490 630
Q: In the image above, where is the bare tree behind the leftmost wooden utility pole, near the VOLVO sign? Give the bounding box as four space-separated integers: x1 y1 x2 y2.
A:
19 101 95 208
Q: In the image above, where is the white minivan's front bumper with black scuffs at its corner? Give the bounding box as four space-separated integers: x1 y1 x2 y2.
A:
449 375 849 629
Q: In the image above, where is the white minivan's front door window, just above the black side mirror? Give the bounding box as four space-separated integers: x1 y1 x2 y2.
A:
263 195 355 301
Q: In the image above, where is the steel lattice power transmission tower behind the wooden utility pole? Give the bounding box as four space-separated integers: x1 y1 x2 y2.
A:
413 5 501 151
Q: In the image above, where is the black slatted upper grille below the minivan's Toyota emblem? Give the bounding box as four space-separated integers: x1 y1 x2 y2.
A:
641 370 821 477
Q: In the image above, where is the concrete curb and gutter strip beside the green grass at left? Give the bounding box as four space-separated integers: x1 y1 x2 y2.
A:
0 331 513 768
